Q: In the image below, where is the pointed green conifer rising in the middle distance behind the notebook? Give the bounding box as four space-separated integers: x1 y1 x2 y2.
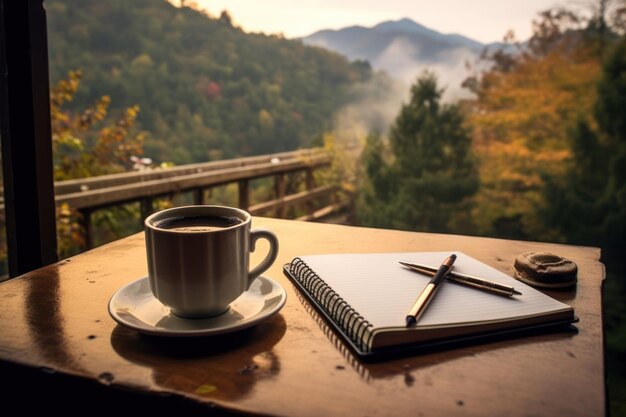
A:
358 72 478 232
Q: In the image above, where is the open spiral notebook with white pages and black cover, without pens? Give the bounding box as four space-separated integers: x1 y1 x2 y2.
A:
283 252 577 356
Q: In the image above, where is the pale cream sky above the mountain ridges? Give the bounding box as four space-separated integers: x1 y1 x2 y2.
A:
189 0 567 43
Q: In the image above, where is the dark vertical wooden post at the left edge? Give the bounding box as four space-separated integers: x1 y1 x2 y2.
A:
0 0 57 277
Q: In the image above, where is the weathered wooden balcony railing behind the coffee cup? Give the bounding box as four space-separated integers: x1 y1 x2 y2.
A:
55 148 354 248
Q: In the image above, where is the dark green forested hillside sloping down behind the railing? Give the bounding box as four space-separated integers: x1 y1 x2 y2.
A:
46 0 372 164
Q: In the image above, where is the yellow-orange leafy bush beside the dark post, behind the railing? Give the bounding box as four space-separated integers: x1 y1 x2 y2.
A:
50 70 144 258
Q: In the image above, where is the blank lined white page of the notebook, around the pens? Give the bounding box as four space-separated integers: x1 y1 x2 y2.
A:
300 251 571 328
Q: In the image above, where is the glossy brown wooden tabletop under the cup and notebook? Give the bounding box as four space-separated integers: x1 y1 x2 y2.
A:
0 218 606 417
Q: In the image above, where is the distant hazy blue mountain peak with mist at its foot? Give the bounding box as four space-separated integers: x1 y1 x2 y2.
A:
302 18 489 98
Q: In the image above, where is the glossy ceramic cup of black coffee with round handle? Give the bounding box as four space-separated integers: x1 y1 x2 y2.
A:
144 205 278 318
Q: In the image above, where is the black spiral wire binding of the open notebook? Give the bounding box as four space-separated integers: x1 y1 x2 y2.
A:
289 258 373 351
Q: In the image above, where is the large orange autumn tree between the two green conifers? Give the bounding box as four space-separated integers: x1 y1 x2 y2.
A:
468 44 600 240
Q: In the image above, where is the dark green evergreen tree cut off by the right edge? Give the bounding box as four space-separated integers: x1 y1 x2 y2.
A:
545 40 626 248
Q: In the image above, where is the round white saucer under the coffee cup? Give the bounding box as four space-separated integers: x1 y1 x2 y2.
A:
109 277 287 337
